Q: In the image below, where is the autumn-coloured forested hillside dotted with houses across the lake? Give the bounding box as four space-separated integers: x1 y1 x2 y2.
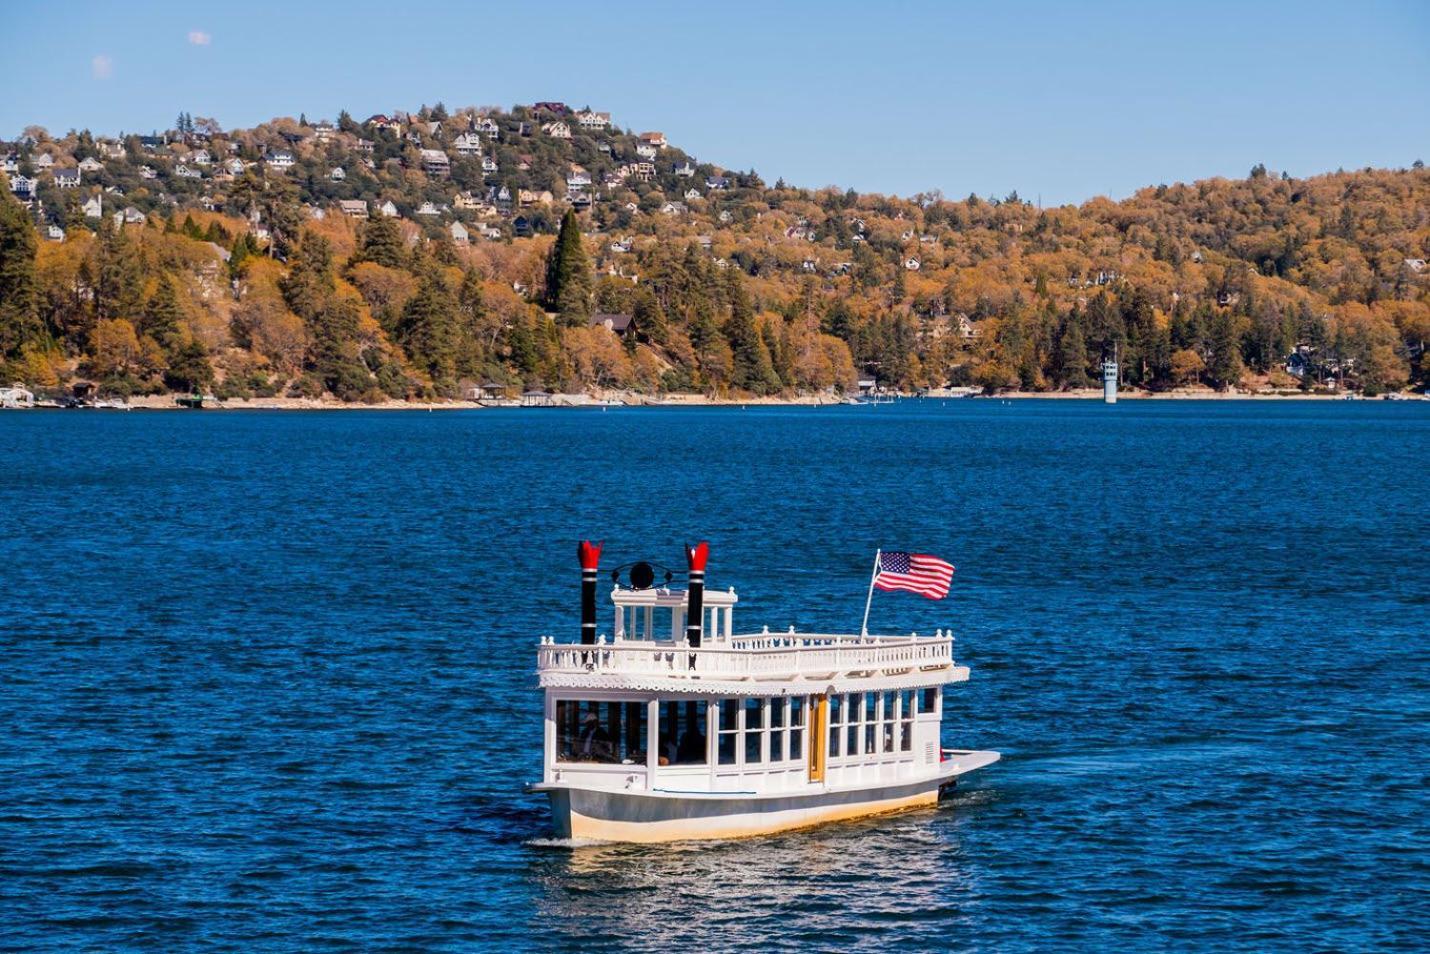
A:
0 103 1430 400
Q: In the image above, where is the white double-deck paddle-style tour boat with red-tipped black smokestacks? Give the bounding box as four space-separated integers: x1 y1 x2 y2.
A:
528 544 998 842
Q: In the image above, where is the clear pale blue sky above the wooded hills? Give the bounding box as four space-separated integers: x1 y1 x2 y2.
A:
0 0 1430 205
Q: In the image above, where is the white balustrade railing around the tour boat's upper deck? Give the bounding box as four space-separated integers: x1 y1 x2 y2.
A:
536 634 954 679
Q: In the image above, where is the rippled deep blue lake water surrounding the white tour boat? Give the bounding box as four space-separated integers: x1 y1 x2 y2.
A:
0 400 1430 951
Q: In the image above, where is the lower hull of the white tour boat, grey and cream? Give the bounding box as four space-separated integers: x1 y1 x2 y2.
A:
533 752 997 842
